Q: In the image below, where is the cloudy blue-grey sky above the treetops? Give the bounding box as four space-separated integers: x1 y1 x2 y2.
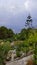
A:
0 0 37 33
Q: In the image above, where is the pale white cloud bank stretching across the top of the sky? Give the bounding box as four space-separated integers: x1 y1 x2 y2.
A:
0 0 37 14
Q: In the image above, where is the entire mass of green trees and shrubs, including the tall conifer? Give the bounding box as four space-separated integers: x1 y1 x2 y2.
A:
0 15 37 65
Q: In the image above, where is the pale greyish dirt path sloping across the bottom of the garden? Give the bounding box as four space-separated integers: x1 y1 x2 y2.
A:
6 55 33 65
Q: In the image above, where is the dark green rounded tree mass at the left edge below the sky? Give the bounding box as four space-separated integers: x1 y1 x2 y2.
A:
0 26 14 40
